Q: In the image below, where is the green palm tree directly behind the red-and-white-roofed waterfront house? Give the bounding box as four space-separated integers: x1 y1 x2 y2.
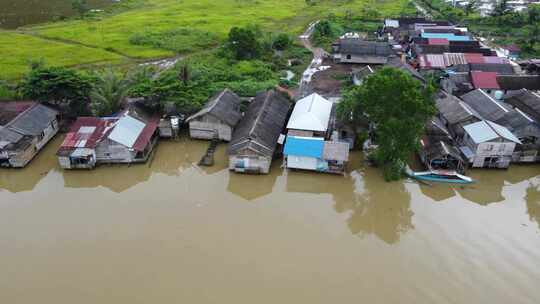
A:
90 68 132 116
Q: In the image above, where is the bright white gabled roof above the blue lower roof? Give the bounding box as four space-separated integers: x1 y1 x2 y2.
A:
287 93 333 132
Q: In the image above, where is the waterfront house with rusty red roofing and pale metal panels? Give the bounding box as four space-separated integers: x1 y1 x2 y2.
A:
57 108 159 169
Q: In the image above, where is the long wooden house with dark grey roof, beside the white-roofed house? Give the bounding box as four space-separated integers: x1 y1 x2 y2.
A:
228 90 290 174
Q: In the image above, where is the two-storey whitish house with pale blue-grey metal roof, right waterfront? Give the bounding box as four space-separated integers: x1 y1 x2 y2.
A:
460 120 521 169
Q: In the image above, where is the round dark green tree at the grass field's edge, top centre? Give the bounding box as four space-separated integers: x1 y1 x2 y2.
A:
228 27 261 60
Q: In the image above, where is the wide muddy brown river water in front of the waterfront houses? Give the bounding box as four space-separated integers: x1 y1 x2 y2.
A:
0 138 540 304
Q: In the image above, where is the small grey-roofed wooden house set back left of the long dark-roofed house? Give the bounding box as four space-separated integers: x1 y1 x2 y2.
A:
186 89 242 141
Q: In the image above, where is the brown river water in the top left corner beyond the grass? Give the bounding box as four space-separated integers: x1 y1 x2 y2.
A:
0 0 113 29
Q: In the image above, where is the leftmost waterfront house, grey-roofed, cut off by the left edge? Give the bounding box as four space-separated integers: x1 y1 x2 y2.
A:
0 101 59 168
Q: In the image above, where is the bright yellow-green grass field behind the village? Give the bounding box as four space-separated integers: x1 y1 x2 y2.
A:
0 0 413 79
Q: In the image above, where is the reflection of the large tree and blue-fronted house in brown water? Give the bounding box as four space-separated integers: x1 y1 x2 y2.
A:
287 153 414 244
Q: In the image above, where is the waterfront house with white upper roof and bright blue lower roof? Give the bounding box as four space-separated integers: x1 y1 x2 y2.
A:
283 93 351 174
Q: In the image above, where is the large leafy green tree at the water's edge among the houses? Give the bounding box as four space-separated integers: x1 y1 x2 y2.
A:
338 68 435 180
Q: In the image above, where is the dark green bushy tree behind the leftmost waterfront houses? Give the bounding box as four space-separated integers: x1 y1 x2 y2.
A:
18 64 93 116
